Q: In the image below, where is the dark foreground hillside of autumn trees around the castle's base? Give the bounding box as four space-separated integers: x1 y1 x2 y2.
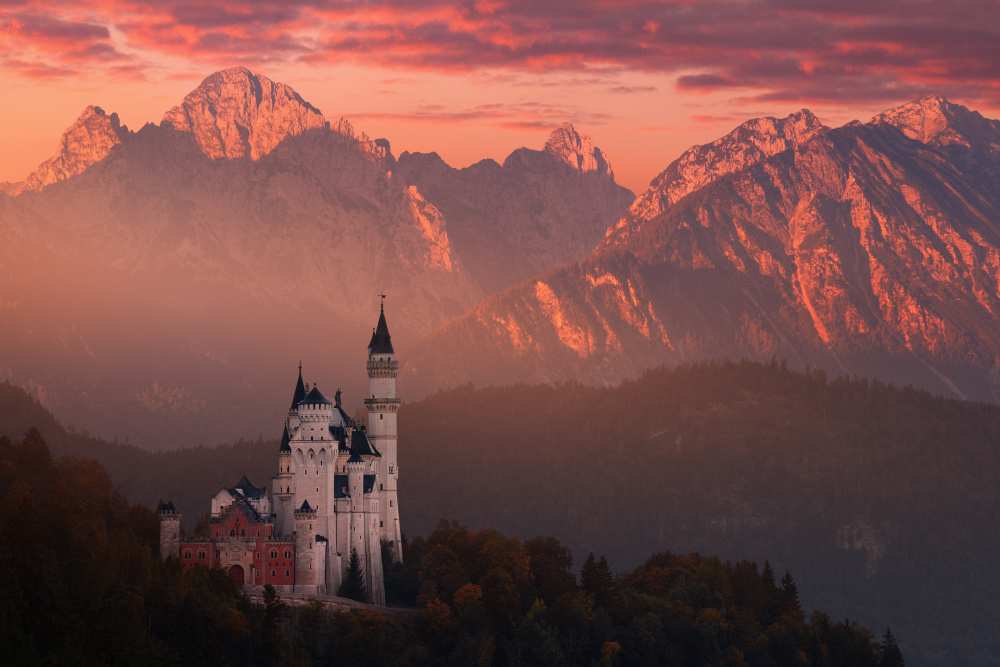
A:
0 431 903 667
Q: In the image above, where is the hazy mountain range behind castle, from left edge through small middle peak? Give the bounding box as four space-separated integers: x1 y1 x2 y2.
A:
0 68 630 447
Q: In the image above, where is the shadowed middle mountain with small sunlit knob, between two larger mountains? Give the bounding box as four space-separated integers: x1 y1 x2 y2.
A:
397 125 633 293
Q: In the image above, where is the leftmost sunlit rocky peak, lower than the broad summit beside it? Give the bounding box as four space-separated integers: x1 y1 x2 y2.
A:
17 105 129 191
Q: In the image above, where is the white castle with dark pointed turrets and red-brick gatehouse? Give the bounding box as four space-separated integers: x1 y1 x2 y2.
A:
158 301 403 605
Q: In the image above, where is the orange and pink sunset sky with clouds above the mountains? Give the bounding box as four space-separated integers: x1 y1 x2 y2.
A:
0 0 1000 192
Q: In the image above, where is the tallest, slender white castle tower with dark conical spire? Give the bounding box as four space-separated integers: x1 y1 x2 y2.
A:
365 294 403 562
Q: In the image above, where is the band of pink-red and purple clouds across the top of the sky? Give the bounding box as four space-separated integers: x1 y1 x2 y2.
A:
0 0 1000 103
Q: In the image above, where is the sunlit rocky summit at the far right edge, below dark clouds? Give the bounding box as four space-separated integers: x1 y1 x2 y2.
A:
871 95 1000 150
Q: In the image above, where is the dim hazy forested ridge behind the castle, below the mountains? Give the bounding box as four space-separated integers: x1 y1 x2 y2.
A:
0 363 1000 665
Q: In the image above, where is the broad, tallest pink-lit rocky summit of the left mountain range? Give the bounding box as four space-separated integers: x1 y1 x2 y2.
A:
163 67 327 160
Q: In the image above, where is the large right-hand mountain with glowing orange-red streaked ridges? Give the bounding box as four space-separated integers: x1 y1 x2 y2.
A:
409 98 1000 400
